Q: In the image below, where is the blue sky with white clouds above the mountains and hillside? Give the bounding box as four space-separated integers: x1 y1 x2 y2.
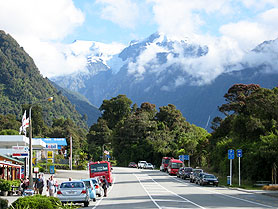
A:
0 0 278 77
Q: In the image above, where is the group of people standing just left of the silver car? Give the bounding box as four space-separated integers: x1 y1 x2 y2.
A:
21 174 58 196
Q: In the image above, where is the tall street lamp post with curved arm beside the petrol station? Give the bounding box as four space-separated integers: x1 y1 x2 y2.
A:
29 97 53 188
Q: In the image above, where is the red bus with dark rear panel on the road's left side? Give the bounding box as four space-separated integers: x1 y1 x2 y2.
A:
89 161 113 185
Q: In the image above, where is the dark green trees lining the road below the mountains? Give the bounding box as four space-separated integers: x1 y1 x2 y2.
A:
0 84 278 181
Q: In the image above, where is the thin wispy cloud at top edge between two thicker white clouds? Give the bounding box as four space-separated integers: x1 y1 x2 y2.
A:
96 0 140 28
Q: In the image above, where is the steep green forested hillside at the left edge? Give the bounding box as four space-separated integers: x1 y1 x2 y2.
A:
0 31 87 128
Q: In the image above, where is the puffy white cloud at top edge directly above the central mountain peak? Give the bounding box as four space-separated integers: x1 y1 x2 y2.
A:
148 0 231 38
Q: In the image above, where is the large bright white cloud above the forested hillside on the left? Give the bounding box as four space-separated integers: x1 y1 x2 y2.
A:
0 0 84 76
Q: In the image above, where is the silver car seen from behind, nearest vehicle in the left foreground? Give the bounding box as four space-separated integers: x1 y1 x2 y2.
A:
57 181 91 207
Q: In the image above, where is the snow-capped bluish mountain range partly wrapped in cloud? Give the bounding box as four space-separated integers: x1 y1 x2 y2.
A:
51 33 278 128
